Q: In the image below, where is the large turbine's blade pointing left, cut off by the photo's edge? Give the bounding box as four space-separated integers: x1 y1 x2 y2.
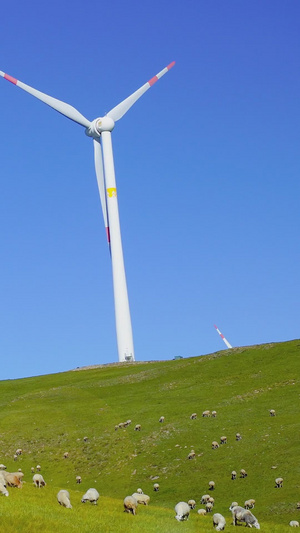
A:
0 70 91 128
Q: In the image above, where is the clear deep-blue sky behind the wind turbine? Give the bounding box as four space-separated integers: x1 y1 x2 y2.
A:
0 0 300 379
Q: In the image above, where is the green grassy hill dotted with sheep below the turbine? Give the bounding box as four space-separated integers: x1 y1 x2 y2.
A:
0 340 300 533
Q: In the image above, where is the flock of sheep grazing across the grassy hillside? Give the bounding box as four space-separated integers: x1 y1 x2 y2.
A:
0 409 300 531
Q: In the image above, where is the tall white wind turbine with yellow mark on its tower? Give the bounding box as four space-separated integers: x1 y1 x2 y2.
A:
0 61 175 362
